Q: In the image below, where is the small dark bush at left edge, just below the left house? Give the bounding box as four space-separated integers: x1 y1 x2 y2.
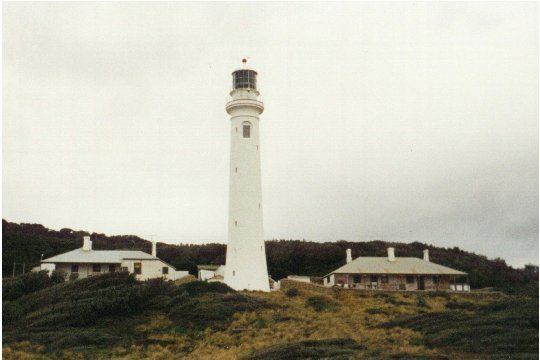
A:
2 271 65 300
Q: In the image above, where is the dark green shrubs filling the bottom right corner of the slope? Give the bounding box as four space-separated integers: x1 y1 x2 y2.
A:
383 297 538 358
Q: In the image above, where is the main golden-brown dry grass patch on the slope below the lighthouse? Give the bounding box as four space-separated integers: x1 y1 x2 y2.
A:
110 290 460 359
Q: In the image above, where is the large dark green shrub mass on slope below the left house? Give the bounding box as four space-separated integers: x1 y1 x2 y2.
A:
2 272 268 349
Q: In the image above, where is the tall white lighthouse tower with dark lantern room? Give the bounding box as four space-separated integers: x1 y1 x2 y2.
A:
225 59 270 291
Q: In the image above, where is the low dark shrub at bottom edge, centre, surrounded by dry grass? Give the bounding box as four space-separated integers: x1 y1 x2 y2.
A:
245 339 365 360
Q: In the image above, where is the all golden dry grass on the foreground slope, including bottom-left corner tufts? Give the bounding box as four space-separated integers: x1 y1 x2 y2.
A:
3 289 520 360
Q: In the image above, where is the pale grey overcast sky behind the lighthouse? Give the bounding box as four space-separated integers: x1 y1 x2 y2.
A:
2 2 538 266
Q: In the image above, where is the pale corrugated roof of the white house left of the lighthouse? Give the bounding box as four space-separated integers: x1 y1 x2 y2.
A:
42 248 159 264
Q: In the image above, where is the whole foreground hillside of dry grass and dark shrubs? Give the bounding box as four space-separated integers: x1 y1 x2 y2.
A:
2 273 538 360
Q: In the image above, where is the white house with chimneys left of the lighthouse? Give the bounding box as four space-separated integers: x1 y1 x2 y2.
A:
40 236 189 280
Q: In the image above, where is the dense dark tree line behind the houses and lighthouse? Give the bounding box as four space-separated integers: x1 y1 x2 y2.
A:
2 220 538 292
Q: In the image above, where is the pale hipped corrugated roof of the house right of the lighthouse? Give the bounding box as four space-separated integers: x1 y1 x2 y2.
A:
325 257 467 276
